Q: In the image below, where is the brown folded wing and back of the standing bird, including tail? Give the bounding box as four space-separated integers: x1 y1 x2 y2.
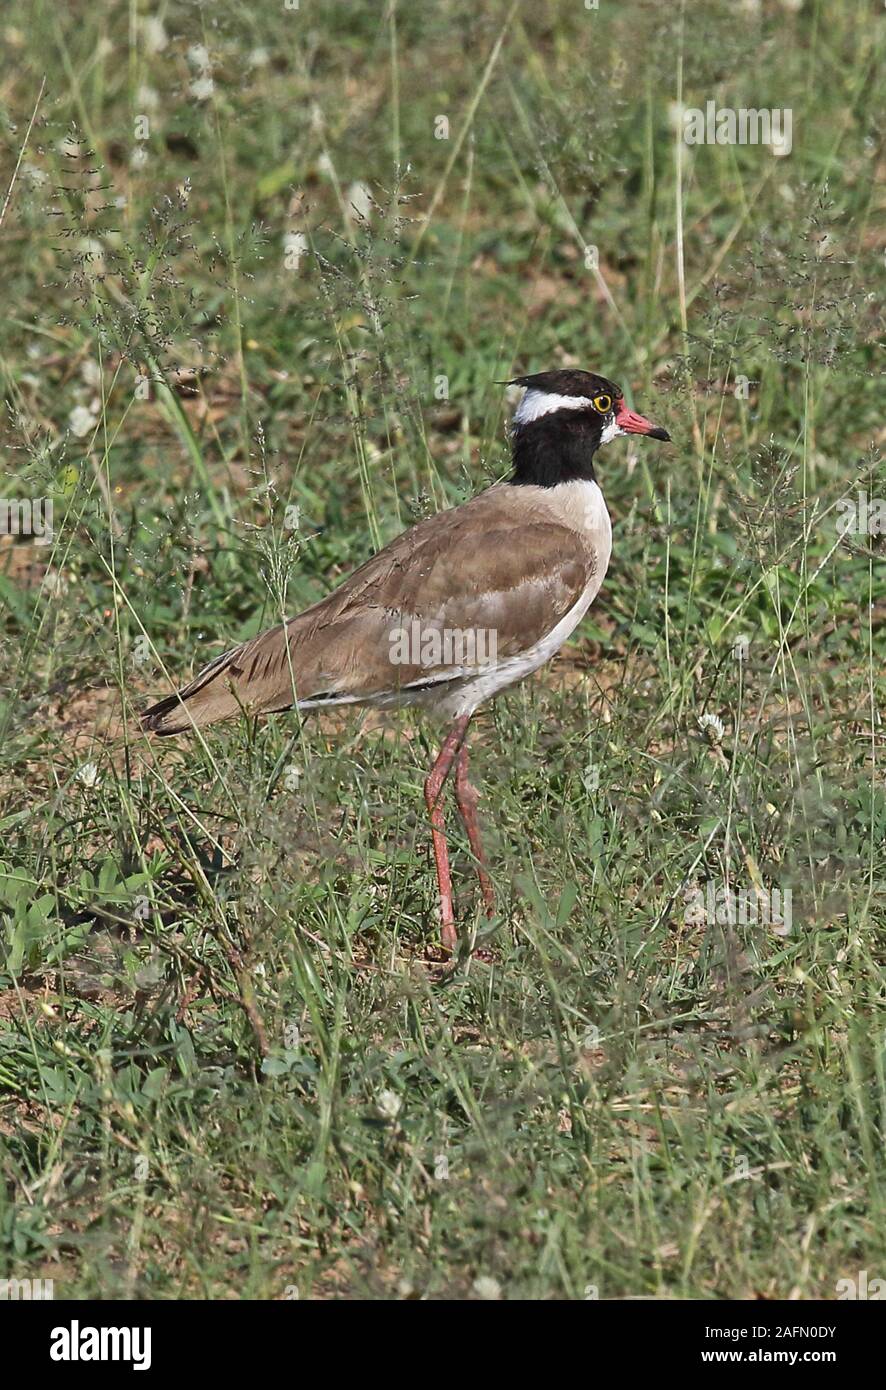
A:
142 487 597 734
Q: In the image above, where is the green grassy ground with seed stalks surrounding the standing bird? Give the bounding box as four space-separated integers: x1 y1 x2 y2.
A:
0 0 886 1298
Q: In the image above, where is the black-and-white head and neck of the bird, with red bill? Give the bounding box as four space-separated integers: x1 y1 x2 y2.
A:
508 368 670 488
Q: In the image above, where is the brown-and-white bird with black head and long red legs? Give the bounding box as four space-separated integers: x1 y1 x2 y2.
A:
142 368 670 958
